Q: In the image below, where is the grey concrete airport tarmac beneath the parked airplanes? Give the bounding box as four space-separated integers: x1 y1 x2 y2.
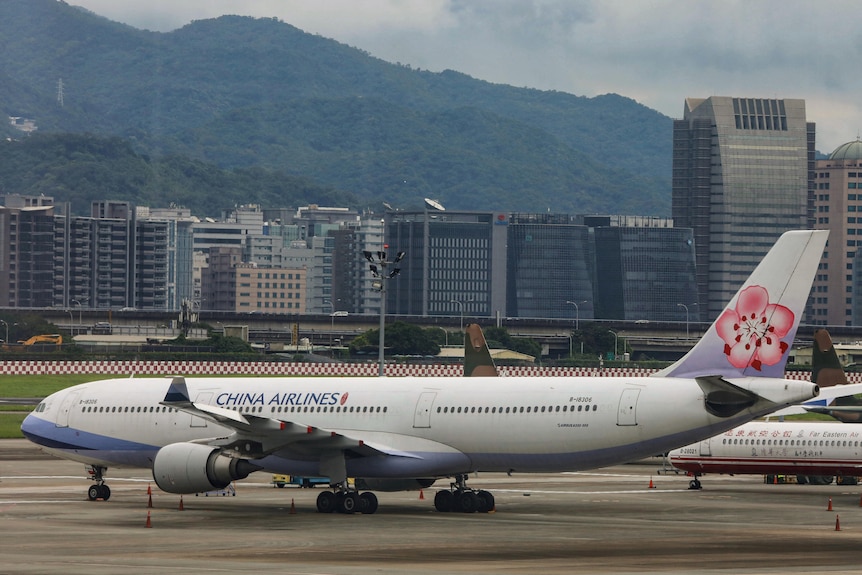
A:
0 440 862 575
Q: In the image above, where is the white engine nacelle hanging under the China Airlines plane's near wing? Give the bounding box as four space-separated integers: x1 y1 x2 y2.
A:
153 443 261 494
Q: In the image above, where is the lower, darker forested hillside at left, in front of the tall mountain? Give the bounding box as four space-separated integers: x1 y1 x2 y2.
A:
0 134 359 217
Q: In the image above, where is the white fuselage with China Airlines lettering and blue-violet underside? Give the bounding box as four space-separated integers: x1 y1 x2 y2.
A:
22 377 816 478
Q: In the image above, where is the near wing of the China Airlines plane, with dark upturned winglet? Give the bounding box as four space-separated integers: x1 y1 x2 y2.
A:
161 377 418 459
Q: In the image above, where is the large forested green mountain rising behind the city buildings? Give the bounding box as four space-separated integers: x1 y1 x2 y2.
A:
0 0 672 215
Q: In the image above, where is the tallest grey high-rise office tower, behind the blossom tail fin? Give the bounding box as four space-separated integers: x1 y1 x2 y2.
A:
672 96 815 320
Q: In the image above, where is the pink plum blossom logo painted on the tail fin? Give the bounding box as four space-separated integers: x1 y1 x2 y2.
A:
716 286 795 371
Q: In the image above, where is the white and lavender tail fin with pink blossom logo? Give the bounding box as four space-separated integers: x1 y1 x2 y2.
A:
654 230 829 378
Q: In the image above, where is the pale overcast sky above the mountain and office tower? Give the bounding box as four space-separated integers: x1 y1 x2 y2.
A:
72 0 862 153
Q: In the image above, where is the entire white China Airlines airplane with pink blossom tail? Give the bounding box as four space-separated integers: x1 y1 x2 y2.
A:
21 231 828 513
